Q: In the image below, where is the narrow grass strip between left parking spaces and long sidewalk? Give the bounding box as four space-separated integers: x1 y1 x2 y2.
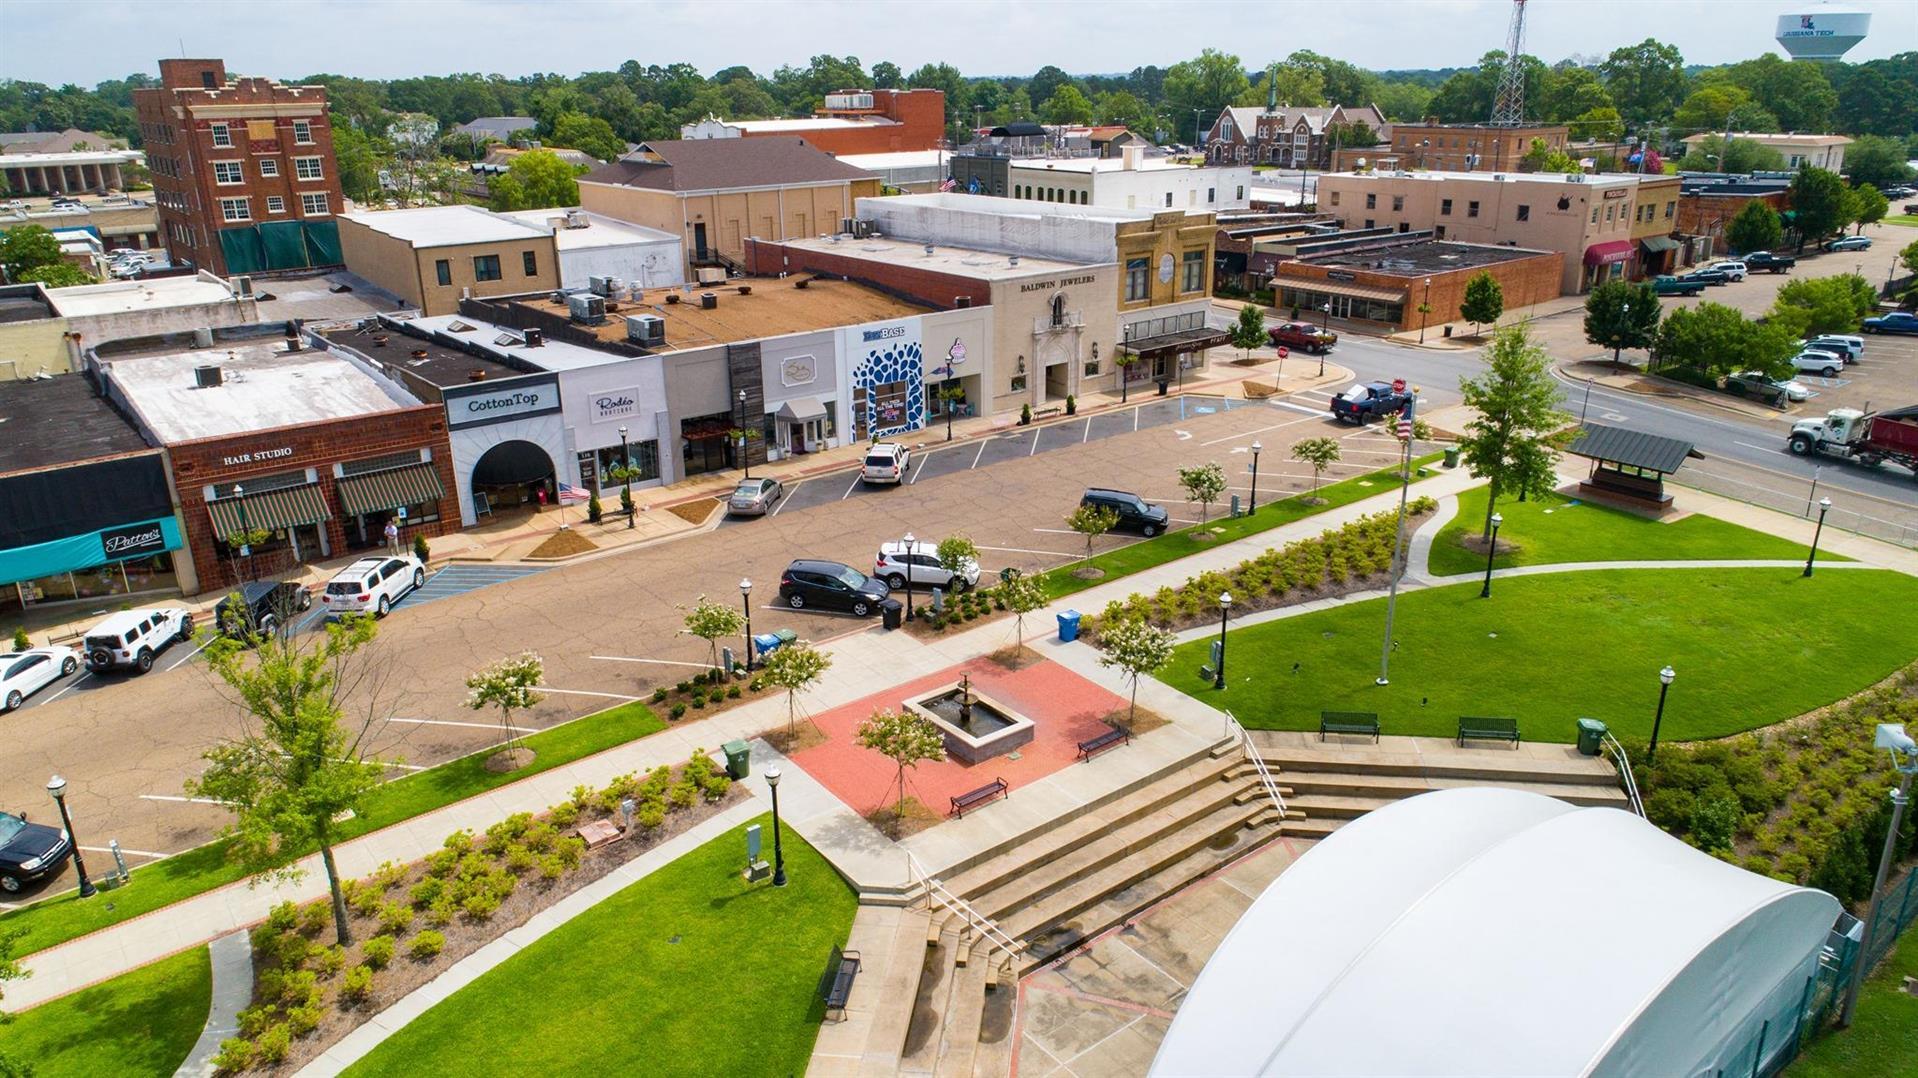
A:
0 700 666 953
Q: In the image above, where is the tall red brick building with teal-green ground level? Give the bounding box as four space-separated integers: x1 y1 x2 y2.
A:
132 59 345 276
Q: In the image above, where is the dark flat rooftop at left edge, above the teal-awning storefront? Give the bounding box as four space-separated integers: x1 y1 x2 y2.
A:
0 374 148 472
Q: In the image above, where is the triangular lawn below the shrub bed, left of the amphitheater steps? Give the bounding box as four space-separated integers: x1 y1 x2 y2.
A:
349 815 855 1076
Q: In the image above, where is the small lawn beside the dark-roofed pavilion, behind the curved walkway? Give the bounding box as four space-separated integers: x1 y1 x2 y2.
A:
1431 487 1851 575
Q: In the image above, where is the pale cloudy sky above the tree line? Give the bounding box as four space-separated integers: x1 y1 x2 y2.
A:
0 0 1918 86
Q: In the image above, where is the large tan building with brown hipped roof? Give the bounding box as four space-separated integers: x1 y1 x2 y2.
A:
579 136 880 276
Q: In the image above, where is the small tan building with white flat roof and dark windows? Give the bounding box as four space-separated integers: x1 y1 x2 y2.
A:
339 205 560 315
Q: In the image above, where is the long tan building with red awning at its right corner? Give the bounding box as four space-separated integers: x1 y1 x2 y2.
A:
1318 171 1638 293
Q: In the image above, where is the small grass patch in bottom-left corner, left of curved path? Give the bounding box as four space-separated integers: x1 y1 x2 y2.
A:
0 948 213 1078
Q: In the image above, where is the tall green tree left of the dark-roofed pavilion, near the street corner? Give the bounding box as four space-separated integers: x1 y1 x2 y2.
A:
1458 318 1563 539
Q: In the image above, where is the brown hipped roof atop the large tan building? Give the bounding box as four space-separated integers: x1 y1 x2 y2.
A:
579 136 873 192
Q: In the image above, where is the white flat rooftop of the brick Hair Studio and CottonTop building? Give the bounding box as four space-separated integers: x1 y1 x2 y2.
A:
102 338 418 445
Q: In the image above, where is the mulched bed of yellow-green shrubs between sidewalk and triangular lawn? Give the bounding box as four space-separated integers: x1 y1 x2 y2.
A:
217 750 746 1074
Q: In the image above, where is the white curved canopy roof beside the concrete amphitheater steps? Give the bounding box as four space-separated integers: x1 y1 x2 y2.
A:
1151 786 1841 1076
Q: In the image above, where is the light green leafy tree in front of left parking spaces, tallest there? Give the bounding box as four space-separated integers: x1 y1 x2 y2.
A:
186 616 386 946
